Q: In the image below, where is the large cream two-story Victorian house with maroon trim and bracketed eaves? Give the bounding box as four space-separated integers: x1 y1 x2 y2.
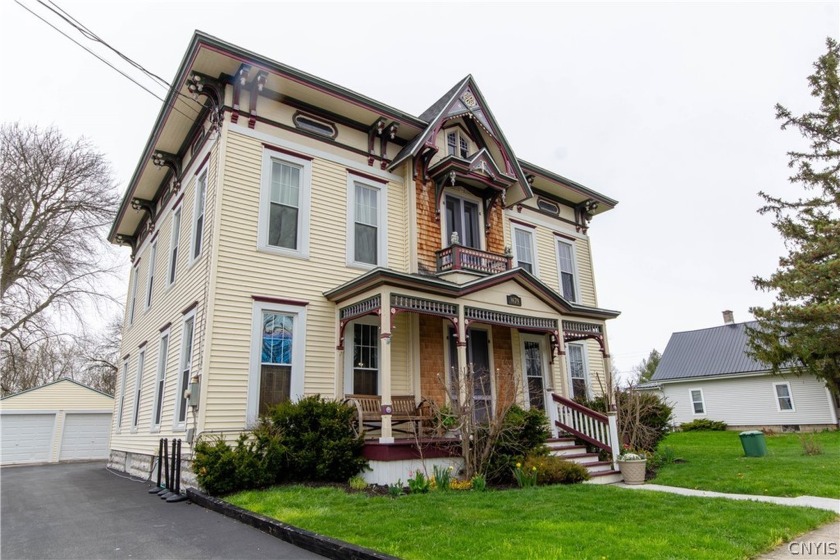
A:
109 33 618 486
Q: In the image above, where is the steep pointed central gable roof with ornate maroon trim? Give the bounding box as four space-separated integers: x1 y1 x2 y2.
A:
389 75 533 202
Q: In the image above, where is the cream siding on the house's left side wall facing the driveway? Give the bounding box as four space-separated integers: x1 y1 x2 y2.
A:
111 136 218 454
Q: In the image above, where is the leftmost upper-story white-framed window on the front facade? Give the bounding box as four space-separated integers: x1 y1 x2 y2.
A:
258 150 312 257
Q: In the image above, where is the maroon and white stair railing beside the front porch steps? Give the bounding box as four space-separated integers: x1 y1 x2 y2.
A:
550 393 620 469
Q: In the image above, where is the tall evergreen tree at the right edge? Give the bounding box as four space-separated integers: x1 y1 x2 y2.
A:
749 38 840 397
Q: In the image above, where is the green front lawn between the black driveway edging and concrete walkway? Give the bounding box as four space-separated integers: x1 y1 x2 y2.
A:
227 485 835 560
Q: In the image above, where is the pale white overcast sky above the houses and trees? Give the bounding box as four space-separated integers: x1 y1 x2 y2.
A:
0 0 840 382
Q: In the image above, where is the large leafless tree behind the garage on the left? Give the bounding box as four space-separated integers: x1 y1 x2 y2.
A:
0 123 118 391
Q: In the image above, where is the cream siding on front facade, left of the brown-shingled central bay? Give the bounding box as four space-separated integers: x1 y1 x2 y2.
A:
202 127 410 431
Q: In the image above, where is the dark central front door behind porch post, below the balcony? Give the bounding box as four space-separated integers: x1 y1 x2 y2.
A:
449 329 493 422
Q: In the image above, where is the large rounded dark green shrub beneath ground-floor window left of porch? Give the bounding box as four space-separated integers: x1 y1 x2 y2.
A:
266 395 367 482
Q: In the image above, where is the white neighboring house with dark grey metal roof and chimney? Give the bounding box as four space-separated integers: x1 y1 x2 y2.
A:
639 311 838 431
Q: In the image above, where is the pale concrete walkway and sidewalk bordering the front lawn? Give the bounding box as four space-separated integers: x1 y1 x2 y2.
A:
615 483 840 560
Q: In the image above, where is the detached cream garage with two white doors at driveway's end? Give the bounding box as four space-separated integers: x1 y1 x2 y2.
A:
0 379 114 465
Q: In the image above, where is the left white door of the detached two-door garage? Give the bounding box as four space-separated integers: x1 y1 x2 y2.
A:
0 414 55 465
